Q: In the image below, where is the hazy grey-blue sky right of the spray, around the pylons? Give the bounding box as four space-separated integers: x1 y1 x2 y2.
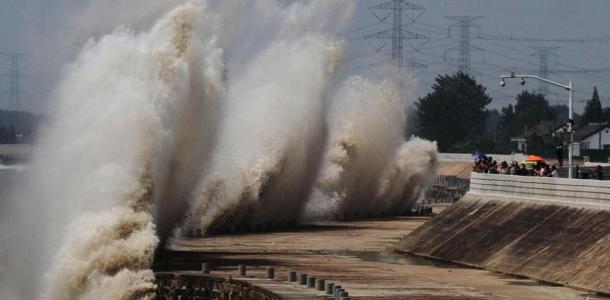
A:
349 0 610 111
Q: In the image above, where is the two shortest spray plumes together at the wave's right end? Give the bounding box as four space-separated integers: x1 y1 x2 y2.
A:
305 76 436 219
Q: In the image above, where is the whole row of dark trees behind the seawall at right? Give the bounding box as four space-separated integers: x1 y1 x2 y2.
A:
414 72 610 154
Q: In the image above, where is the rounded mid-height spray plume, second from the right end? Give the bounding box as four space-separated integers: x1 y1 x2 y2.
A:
308 76 405 217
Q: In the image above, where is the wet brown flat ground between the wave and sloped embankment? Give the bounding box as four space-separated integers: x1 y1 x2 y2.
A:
168 217 602 300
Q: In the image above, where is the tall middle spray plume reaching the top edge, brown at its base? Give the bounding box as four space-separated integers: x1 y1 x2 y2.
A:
177 1 354 235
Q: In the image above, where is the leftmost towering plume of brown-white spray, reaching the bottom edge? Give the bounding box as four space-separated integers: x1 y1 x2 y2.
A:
19 4 214 299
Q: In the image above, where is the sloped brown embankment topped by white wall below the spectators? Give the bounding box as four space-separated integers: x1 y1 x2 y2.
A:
399 173 610 294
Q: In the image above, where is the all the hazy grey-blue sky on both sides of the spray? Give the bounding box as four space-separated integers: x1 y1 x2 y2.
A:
0 0 610 111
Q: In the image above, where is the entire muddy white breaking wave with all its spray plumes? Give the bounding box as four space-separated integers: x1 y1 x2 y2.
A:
2 0 436 299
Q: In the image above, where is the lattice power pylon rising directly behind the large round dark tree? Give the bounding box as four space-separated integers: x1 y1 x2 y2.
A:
444 16 484 74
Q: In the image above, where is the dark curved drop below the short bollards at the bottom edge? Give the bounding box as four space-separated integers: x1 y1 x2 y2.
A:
155 273 281 300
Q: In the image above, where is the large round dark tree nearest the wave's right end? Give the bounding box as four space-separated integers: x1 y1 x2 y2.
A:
415 72 491 151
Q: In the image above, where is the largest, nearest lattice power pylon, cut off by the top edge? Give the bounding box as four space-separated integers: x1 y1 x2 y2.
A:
364 0 430 70
